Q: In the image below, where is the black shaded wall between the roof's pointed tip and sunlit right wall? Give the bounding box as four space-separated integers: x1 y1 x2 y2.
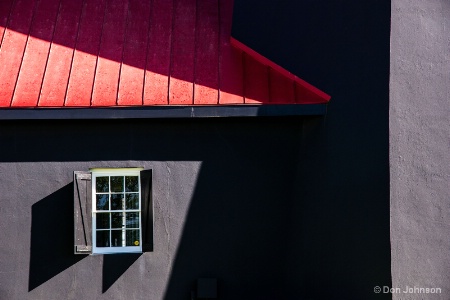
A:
232 0 391 299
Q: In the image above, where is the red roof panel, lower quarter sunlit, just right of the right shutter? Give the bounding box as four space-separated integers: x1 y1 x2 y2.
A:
169 0 196 105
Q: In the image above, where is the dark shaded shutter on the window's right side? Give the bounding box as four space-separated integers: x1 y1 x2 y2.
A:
141 170 153 252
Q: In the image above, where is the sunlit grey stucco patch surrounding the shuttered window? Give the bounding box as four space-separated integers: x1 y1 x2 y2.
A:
0 161 201 299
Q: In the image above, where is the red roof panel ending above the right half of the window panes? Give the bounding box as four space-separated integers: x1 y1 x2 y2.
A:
117 0 151 105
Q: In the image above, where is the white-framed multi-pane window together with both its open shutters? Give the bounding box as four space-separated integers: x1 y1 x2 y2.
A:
74 168 153 254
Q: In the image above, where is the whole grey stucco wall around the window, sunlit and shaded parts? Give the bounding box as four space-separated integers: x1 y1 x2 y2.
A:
0 117 310 300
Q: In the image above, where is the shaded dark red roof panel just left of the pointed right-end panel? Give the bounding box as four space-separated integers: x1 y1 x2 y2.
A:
269 69 295 104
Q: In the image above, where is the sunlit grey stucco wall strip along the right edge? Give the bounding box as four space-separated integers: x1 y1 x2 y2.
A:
390 0 450 299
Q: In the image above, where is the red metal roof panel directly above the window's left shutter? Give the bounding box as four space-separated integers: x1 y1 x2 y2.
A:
65 0 106 106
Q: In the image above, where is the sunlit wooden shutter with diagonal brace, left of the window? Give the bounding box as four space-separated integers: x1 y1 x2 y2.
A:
73 171 92 254
